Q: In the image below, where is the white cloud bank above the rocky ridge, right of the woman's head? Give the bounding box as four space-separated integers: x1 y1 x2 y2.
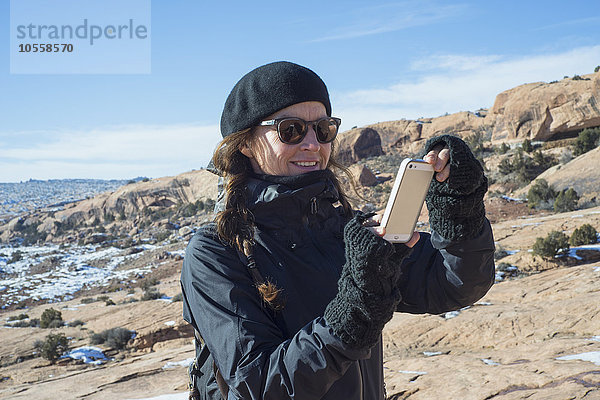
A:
335 45 600 128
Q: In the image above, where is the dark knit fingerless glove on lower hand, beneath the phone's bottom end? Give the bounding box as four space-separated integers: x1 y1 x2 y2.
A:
325 214 411 349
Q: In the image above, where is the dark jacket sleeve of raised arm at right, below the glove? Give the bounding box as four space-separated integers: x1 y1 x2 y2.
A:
396 218 495 314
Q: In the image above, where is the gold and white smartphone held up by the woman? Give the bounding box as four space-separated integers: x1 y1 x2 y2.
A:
381 158 434 243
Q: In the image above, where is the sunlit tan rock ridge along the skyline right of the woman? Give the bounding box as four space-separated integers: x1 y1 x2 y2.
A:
341 72 600 162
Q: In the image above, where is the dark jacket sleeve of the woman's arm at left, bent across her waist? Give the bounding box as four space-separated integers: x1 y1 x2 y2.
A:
181 230 370 399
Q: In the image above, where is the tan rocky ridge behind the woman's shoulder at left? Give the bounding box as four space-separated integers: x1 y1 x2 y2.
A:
0 170 217 243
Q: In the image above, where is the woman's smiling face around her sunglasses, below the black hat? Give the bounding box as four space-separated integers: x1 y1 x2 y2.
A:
240 101 331 176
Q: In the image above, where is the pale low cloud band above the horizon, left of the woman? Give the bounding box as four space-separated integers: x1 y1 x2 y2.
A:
0 125 220 182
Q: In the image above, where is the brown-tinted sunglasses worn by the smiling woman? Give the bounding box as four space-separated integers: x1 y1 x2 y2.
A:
259 117 342 144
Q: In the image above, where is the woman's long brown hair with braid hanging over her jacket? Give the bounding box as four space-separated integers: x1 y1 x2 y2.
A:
212 128 355 310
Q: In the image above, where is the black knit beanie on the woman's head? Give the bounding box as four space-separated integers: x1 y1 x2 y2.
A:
221 61 331 137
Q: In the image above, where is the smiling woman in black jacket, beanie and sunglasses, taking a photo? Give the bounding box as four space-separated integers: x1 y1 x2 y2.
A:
181 62 494 400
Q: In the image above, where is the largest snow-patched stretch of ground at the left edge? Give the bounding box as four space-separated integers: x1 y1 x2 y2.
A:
0 244 165 308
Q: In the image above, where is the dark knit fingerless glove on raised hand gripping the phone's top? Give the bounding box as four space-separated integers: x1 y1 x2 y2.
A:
425 135 488 240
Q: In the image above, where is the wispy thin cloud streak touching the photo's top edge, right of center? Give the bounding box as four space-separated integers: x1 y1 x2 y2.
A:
309 1 465 43
